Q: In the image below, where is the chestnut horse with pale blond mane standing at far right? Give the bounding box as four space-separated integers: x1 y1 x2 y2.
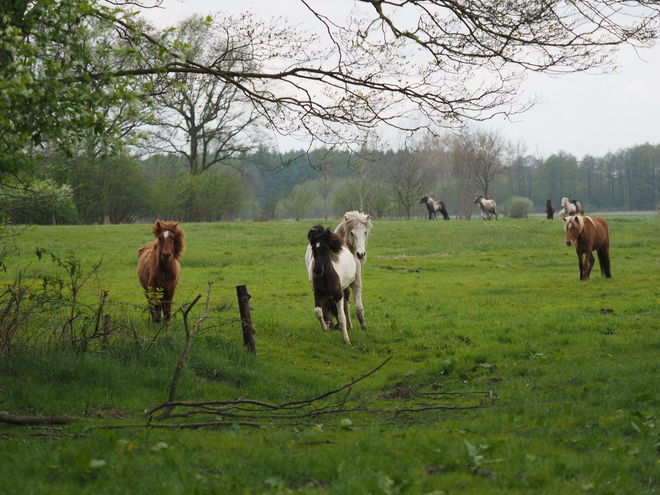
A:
564 215 612 280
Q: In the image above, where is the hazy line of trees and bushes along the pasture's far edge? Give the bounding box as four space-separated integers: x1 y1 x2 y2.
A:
0 132 660 224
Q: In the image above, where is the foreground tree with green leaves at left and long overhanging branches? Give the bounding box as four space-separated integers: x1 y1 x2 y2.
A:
0 0 660 172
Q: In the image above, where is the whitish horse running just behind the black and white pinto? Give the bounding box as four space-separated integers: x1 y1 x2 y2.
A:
335 210 372 332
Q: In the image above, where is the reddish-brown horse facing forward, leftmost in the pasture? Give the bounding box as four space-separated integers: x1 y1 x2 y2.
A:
138 220 185 323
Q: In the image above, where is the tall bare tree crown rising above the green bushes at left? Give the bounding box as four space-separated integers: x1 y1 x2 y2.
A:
149 17 263 175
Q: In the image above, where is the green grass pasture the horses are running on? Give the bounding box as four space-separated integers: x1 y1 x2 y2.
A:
0 217 660 494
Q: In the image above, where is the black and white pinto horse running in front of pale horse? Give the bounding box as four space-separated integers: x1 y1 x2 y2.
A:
305 224 356 344
